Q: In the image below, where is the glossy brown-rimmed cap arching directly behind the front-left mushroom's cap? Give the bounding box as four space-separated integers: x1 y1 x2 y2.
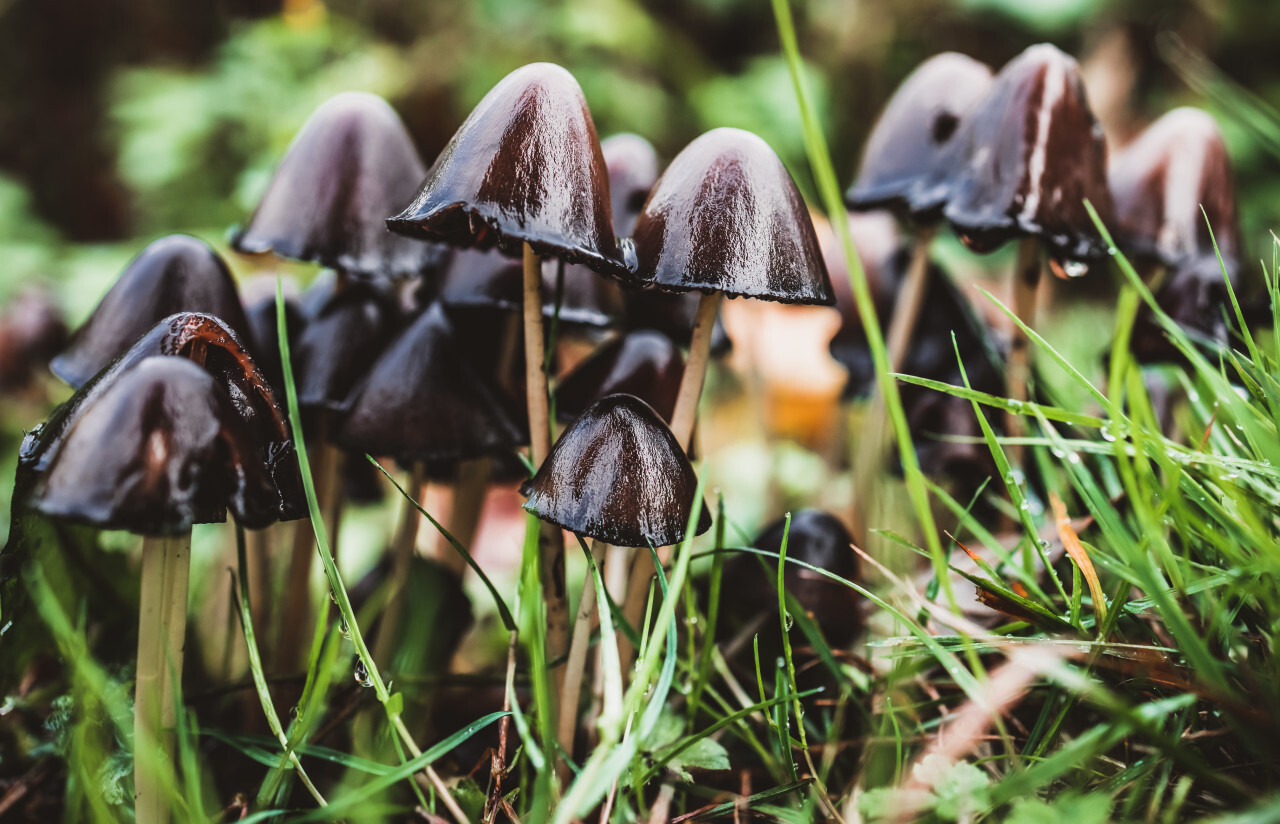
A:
18 312 306 521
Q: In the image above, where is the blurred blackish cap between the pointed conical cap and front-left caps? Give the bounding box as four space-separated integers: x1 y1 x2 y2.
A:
291 278 398 416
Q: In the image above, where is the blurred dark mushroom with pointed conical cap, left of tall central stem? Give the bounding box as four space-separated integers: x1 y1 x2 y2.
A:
338 305 529 660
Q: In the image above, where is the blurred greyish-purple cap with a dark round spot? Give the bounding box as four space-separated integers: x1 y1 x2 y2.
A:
845 51 991 221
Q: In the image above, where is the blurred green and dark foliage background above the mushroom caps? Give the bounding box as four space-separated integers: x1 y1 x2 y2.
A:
0 0 1280 332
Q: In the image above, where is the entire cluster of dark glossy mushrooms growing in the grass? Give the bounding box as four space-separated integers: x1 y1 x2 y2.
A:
0 45 1239 824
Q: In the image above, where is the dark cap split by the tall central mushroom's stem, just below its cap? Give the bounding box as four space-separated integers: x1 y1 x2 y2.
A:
440 250 623 328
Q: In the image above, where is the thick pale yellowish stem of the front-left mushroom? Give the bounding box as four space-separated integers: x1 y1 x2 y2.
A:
133 530 191 824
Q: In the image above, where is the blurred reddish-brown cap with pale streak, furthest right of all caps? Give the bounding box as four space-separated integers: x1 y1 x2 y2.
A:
1110 107 1240 283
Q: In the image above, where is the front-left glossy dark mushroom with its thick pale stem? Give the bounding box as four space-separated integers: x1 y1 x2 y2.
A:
27 352 296 824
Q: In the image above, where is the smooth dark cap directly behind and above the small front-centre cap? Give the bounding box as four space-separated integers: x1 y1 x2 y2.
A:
556 329 685 421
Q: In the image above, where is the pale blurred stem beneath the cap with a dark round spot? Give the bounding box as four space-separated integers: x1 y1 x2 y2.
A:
850 226 937 541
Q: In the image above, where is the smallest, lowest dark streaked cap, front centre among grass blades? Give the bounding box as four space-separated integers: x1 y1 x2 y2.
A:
520 395 712 546
